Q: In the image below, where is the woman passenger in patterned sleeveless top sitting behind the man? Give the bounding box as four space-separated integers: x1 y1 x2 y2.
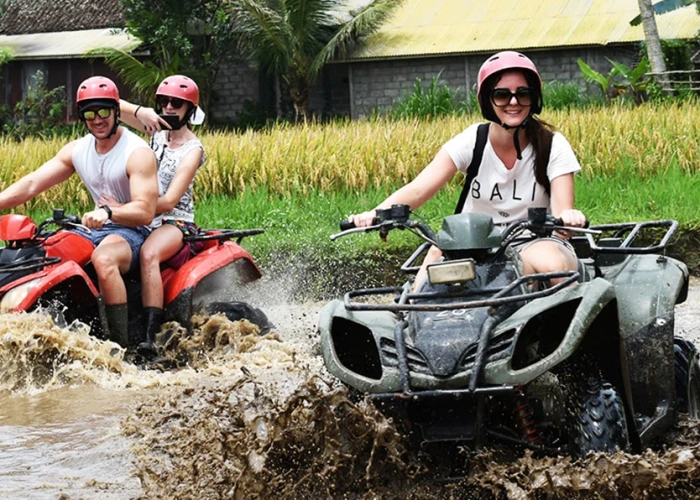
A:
110 75 206 357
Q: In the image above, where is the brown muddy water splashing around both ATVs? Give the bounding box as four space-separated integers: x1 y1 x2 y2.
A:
0 281 700 499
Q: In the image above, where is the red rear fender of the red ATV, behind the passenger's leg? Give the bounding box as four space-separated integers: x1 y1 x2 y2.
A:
163 241 262 329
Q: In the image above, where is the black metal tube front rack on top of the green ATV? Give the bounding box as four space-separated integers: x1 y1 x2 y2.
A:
344 271 580 312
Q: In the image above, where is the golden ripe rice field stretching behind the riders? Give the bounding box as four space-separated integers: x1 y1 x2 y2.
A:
0 102 700 224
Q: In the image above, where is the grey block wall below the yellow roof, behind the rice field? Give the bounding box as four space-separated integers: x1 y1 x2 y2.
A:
211 44 639 123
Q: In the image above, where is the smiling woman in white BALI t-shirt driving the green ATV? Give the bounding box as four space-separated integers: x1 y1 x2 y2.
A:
348 51 586 286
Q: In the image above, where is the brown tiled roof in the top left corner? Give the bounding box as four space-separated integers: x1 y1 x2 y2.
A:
0 0 124 35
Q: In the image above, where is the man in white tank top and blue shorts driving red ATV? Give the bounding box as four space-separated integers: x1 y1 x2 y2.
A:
0 76 158 347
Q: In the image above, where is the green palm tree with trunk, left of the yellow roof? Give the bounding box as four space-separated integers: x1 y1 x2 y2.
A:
229 0 402 121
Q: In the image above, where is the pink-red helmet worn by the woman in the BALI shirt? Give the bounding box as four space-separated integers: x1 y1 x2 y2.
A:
476 50 542 122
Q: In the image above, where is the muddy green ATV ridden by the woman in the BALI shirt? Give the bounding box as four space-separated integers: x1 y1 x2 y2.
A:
319 205 700 457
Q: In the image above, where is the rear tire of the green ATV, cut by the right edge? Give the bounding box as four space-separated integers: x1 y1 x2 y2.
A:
673 337 700 418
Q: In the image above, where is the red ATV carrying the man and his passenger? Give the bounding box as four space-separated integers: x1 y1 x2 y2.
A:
0 209 271 346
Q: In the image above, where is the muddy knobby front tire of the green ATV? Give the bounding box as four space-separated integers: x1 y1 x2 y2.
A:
569 376 629 458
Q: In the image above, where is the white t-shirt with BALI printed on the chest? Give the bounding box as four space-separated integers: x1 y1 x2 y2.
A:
443 123 581 224
